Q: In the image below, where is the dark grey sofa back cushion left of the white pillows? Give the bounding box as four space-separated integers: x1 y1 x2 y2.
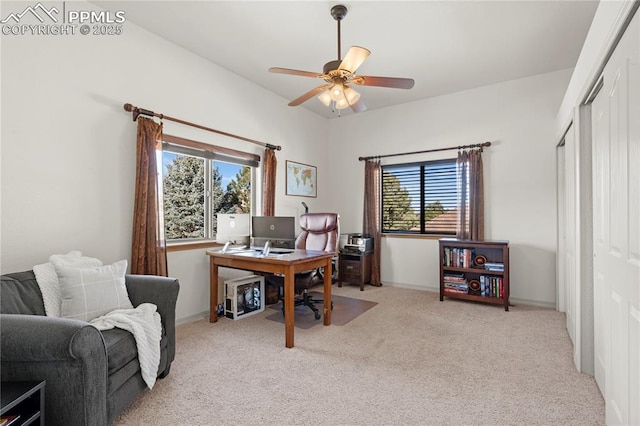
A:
0 271 45 315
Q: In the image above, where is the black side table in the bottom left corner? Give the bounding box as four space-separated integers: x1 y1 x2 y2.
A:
0 381 45 426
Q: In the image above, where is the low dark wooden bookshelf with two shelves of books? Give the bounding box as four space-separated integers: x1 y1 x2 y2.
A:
440 238 509 311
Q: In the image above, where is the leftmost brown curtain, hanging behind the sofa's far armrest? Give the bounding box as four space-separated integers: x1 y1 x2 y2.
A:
131 117 167 277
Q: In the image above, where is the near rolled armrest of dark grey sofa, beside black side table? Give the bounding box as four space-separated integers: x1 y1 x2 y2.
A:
0 314 107 425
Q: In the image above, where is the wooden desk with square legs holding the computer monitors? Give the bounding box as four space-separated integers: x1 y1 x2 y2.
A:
207 250 334 348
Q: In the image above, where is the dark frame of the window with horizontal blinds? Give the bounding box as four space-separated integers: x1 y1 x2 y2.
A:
380 157 460 238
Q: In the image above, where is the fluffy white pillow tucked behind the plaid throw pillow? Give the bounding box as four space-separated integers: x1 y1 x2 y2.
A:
33 250 102 317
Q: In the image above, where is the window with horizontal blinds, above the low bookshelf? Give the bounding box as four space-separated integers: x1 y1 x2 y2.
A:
382 159 468 235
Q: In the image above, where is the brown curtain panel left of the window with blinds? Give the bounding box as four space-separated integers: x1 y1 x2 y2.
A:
362 160 382 286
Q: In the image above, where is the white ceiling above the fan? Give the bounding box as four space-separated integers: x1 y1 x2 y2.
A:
92 0 598 118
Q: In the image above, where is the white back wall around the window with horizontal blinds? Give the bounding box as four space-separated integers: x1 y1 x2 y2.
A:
330 70 571 306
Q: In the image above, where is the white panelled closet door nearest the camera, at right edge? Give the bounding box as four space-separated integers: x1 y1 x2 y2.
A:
592 14 640 425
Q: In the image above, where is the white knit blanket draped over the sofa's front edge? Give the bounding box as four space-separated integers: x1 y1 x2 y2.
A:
89 303 162 389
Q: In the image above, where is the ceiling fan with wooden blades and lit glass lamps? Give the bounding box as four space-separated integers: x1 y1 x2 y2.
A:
269 4 414 112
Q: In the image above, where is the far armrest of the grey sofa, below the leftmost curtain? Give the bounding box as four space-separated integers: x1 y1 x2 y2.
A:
125 275 180 363
